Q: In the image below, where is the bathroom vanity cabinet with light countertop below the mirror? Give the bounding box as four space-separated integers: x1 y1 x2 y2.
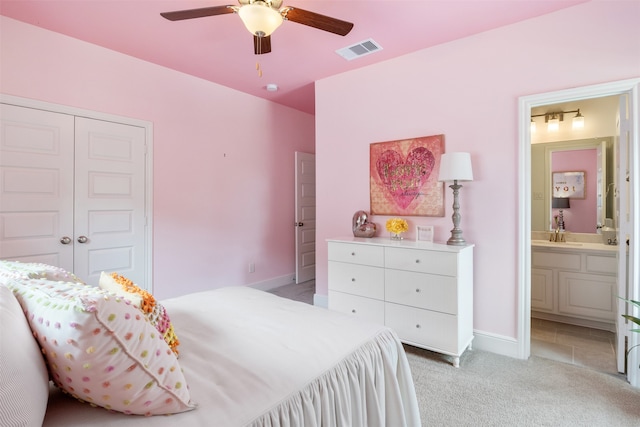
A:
531 240 618 332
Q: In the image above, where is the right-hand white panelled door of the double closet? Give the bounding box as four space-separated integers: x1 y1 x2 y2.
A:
73 117 147 287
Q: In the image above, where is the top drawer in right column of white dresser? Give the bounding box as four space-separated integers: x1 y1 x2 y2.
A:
384 247 457 276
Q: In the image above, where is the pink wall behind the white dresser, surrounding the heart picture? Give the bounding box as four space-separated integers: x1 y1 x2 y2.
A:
316 1 640 343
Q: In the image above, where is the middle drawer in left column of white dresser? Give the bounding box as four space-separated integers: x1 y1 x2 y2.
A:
328 261 384 299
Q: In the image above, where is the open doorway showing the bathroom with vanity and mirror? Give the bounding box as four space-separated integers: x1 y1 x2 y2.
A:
530 95 620 374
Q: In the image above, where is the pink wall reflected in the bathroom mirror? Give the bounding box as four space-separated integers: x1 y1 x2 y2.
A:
551 148 598 233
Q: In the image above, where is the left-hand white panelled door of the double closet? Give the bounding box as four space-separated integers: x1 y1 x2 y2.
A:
0 104 74 271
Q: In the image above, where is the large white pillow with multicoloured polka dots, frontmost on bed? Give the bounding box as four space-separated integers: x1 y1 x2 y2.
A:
8 279 195 415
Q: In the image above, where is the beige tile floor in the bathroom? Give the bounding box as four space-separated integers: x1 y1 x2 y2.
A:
531 318 618 374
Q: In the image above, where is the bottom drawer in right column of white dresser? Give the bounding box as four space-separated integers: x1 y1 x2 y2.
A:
385 303 459 354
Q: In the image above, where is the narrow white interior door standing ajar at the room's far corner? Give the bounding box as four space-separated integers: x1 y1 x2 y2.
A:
295 152 316 283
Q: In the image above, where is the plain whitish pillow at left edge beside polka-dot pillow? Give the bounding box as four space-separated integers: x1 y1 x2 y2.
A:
0 285 49 426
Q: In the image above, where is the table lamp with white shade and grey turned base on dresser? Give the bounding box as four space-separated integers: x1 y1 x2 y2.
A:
438 153 473 246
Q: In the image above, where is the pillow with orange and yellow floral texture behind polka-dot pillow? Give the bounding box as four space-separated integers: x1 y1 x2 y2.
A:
98 271 180 354
